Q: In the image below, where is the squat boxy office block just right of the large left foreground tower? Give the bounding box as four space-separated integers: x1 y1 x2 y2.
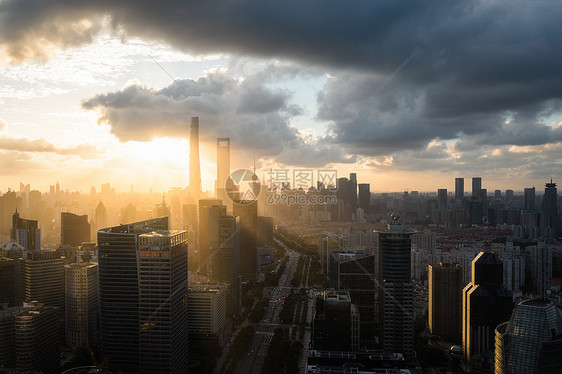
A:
187 284 227 346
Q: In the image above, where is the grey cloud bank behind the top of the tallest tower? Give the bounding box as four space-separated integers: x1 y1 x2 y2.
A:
82 71 352 166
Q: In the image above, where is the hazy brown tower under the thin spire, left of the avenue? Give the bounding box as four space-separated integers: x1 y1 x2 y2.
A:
233 201 258 281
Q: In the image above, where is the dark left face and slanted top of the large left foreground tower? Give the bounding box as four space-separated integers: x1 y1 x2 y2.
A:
98 217 168 372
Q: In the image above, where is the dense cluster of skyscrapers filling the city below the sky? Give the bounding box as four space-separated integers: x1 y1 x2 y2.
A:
0 117 562 374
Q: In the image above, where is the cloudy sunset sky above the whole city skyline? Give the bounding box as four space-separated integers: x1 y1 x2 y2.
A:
0 0 562 191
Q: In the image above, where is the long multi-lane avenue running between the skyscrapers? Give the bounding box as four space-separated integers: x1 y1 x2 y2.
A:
236 242 301 374
